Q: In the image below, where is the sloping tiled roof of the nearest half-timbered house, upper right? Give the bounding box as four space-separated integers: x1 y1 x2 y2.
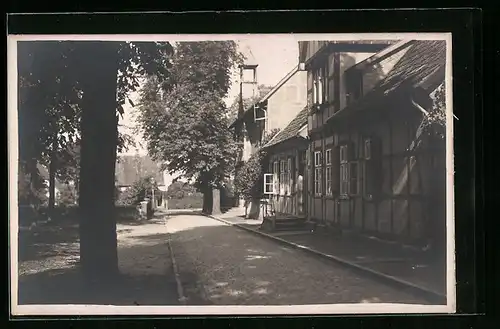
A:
329 40 446 121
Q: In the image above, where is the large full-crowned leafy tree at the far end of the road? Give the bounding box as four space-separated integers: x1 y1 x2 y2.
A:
138 41 242 213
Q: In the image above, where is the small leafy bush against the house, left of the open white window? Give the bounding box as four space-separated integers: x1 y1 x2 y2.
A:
234 129 279 200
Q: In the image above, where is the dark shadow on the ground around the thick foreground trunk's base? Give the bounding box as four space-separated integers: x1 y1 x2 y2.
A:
18 237 182 305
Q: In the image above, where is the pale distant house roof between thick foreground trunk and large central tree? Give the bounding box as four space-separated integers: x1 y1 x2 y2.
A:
115 155 164 186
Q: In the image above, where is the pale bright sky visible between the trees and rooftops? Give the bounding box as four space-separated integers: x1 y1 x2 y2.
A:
119 35 299 154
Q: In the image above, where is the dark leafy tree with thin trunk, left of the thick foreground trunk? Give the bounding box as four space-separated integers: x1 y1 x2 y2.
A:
18 41 81 214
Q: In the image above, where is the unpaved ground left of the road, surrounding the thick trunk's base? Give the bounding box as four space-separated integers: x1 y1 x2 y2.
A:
18 217 178 305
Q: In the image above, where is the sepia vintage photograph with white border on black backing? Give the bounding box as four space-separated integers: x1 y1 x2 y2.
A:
8 33 455 315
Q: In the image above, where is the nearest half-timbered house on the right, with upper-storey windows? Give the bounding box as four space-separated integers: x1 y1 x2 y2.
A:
292 40 446 242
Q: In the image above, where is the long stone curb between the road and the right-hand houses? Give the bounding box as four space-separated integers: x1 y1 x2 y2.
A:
203 214 446 304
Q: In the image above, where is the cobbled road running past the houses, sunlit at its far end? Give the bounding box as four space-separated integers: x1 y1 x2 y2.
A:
166 214 427 305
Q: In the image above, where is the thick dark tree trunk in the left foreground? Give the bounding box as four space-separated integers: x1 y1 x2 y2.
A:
79 42 118 282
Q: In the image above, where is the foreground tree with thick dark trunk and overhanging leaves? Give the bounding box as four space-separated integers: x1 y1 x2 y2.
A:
18 41 172 279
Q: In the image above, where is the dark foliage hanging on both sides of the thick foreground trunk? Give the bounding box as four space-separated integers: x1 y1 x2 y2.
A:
18 41 146 200
